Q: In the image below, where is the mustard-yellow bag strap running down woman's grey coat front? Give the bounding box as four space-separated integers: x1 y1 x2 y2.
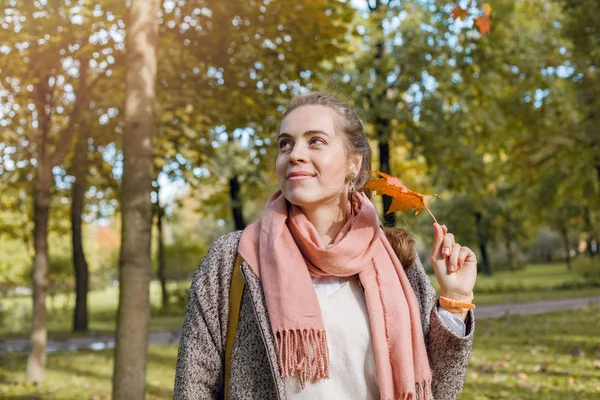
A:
225 253 246 399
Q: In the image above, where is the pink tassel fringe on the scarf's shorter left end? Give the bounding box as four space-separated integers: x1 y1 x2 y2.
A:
275 329 329 389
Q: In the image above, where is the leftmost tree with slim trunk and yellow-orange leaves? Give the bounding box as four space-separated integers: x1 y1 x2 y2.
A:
0 2 113 382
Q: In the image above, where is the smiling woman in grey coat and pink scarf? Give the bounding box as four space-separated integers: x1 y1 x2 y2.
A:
174 93 477 400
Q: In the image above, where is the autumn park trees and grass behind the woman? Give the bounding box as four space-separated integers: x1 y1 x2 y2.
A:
0 0 600 399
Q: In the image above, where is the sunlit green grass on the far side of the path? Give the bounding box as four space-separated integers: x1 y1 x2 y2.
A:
0 263 600 339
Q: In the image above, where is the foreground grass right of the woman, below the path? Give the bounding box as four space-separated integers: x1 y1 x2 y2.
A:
460 306 600 400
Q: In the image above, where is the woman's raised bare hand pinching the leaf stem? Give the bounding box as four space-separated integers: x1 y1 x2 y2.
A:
431 223 477 319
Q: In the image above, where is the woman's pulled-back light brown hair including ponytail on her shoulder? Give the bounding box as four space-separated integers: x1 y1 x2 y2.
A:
283 92 416 269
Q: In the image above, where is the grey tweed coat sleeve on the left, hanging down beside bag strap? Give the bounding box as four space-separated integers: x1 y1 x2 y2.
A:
173 232 239 400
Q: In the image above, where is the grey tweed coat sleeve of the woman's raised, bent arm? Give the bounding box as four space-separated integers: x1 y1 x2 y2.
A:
407 256 475 400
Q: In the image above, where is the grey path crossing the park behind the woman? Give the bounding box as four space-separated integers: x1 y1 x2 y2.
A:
0 296 600 356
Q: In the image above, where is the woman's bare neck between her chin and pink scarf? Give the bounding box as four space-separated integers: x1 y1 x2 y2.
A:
302 195 346 247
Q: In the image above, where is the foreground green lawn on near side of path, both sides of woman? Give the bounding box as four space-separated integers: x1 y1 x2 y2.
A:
0 306 600 400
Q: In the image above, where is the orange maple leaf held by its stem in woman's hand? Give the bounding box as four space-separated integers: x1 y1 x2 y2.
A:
365 171 437 222
